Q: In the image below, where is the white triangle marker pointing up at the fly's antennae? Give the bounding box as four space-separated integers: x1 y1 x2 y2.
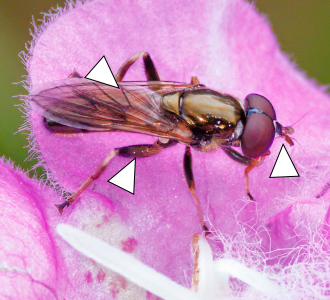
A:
269 144 300 178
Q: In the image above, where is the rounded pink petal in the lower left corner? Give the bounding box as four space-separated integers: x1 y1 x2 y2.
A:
0 160 56 299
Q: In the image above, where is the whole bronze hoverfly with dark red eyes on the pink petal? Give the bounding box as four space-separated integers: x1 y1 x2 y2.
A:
31 52 294 229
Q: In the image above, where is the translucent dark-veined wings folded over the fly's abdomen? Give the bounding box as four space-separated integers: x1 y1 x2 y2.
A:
31 78 191 142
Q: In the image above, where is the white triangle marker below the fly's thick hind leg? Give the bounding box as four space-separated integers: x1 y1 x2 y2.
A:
108 158 136 195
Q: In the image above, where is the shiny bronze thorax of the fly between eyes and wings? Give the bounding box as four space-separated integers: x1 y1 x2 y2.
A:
161 85 245 152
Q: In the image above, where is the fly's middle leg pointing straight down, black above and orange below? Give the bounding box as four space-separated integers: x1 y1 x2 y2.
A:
184 146 209 232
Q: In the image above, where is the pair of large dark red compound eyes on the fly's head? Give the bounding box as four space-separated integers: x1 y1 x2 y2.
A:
241 94 276 158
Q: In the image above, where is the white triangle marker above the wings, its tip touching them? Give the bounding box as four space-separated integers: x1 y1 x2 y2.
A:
85 56 119 88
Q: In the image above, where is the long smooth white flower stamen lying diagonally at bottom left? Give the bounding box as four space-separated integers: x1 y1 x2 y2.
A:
56 224 203 300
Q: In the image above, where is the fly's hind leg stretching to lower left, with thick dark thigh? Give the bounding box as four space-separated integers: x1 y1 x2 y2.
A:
56 140 177 214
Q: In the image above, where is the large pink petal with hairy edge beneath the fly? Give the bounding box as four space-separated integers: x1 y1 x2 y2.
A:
21 0 330 296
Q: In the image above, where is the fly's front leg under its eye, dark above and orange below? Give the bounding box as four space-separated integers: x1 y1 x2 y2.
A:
222 147 270 200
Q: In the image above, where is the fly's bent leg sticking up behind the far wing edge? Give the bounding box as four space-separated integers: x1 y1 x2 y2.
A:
116 52 160 81
